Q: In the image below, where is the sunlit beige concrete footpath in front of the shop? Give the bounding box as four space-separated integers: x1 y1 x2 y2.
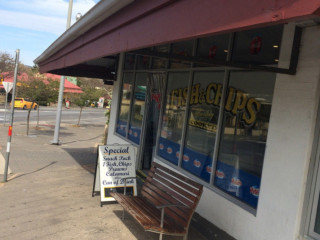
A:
0 122 206 240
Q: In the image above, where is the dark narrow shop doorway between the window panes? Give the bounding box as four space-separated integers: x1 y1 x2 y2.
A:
139 73 165 170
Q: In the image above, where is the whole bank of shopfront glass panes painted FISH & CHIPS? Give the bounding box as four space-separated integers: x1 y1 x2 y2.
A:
116 23 283 210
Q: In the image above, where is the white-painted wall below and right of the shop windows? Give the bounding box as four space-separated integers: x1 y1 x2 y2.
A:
197 27 320 240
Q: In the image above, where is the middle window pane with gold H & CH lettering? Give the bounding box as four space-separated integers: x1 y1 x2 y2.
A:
182 72 224 182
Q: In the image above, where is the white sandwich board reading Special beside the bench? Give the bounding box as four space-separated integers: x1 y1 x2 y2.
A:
93 145 137 206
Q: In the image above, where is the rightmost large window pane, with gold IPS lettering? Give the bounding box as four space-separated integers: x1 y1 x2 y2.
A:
214 71 275 208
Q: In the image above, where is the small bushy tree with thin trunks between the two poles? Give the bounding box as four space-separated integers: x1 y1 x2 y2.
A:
17 72 59 135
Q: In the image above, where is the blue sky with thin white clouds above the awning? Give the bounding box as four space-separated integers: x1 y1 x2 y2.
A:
0 0 99 66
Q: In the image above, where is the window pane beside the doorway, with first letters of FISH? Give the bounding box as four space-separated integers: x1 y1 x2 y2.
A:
158 72 189 165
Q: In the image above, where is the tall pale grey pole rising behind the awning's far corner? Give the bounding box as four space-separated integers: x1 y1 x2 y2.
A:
51 0 73 145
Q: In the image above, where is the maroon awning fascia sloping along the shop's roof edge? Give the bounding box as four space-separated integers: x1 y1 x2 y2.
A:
35 0 320 73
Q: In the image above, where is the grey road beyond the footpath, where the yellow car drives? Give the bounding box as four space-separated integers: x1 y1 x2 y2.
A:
0 106 106 124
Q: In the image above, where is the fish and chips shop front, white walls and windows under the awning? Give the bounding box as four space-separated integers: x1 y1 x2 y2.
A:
37 1 320 240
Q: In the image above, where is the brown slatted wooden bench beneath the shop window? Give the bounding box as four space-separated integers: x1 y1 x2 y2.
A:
111 162 203 240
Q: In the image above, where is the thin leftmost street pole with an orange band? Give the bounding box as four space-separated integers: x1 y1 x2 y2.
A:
3 49 20 182
